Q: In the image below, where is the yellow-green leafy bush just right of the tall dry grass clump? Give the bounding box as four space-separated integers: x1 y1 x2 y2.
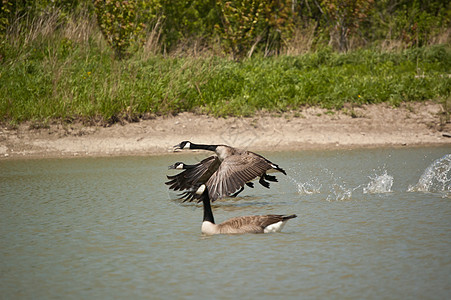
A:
94 0 146 59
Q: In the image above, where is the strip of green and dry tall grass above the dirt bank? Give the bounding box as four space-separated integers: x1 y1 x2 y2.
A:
0 12 451 123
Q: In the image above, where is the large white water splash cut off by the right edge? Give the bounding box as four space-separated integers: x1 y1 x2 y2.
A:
407 154 451 198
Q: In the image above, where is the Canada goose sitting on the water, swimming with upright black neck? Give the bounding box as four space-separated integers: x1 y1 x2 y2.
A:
195 184 297 235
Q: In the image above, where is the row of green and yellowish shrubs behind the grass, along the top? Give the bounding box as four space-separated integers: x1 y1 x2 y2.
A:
0 0 451 59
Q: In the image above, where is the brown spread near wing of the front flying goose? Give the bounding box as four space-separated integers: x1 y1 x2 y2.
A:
206 152 272 201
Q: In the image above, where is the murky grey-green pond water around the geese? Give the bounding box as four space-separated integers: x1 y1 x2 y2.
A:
0 147 451 299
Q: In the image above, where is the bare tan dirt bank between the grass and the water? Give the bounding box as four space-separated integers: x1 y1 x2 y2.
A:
0 103 451 159
